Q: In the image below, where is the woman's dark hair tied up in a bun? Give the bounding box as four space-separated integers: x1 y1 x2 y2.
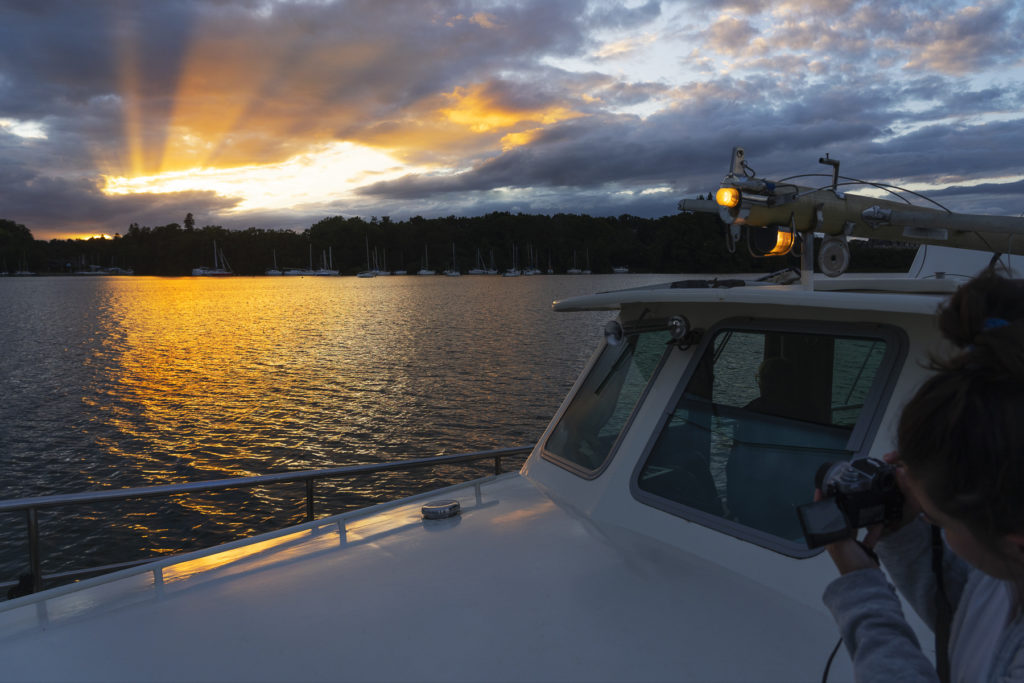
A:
897 270 1024 545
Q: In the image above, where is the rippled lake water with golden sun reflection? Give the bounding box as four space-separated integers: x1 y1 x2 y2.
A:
0 274 679 582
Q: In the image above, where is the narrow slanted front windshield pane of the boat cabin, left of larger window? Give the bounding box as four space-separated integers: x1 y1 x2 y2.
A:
544 332 670 471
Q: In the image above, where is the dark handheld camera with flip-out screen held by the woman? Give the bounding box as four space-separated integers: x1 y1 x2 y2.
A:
797 458 903 548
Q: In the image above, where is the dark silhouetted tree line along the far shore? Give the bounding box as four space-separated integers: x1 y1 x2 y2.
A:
0 212 913 275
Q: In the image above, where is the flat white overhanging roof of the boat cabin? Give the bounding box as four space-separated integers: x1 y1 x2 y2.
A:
552 278 961 315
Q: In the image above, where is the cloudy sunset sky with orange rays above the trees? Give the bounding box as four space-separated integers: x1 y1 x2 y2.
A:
0 0 1024 239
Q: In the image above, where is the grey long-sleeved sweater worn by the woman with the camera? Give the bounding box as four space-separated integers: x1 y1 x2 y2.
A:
824 520 1024 683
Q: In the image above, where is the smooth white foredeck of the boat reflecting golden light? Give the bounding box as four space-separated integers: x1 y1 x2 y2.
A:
0 474 846 681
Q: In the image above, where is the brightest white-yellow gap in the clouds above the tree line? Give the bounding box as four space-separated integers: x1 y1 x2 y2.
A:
103 142 422 212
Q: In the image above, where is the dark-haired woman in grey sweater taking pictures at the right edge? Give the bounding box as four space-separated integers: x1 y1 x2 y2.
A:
824 272 1024 682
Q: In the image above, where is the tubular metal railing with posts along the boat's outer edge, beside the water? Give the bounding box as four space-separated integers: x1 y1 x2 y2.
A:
0 445 534 592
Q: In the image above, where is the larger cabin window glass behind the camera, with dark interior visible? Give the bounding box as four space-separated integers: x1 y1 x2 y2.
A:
637 330 886 541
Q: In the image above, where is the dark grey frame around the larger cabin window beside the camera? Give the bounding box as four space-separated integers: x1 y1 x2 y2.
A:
624 317 908 559
